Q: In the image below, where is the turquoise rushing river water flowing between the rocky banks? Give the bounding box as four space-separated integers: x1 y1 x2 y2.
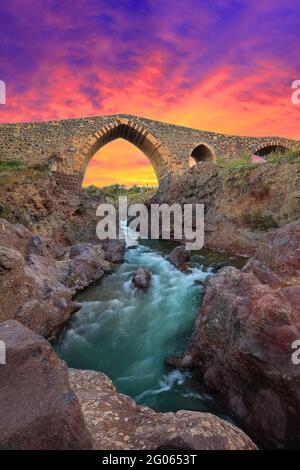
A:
54 229 244 416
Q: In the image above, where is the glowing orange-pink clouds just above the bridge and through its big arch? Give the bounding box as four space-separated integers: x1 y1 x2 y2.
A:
0 31 300 186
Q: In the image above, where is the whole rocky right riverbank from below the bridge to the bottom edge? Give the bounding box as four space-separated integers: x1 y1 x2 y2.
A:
150 161 300 448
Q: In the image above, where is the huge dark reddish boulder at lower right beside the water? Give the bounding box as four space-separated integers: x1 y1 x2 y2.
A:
182 260 300 448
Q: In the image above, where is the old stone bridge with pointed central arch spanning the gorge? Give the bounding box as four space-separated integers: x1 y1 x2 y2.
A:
0 114 300 190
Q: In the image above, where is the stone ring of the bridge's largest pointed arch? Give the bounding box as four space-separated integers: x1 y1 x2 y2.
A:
80 118 171 184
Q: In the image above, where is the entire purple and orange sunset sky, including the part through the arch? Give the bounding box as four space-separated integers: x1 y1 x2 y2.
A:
0 0 300 185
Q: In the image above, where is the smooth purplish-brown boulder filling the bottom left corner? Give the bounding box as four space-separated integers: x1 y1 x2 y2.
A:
0 320 92 450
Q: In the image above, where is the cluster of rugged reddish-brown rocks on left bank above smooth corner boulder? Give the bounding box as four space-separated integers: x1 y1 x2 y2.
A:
0 220 110 339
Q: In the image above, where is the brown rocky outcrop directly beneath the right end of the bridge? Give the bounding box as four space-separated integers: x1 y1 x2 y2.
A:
154 160 300 262
